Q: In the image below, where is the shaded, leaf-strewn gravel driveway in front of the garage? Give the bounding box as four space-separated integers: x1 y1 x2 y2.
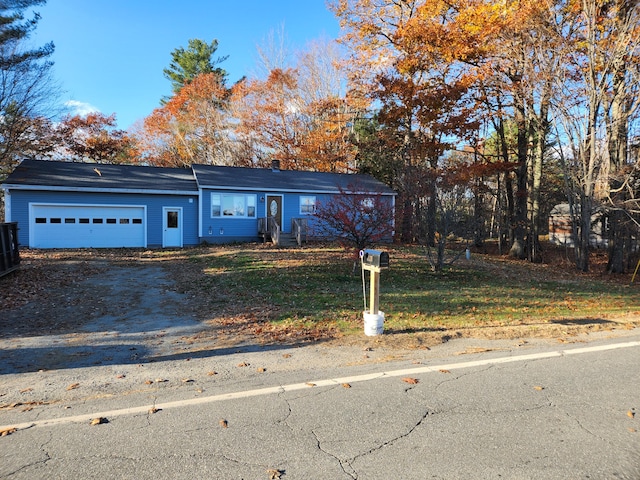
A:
0 264 214 374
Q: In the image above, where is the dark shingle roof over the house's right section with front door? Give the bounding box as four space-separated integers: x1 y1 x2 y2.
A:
192 165 395 195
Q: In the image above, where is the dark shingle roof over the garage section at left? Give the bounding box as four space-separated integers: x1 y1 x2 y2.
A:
4 160 198 193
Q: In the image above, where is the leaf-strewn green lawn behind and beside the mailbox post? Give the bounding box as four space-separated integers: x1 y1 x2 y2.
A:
179 245 640 334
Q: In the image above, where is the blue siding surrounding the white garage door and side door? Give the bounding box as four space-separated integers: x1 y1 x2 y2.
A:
11 190 199 247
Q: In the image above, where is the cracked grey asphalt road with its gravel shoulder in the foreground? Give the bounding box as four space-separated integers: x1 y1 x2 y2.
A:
0 330 640 480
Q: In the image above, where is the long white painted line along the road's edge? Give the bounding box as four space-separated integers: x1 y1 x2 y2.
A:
0 341 640 431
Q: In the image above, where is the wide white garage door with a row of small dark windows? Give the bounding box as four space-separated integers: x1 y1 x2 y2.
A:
29 203 147 248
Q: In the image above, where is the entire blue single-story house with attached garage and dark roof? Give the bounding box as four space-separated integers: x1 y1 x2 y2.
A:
2 160 396 248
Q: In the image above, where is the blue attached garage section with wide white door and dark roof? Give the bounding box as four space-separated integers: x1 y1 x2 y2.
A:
0 160 200 248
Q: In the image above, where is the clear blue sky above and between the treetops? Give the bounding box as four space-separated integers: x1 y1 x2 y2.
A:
32 0 339 129
